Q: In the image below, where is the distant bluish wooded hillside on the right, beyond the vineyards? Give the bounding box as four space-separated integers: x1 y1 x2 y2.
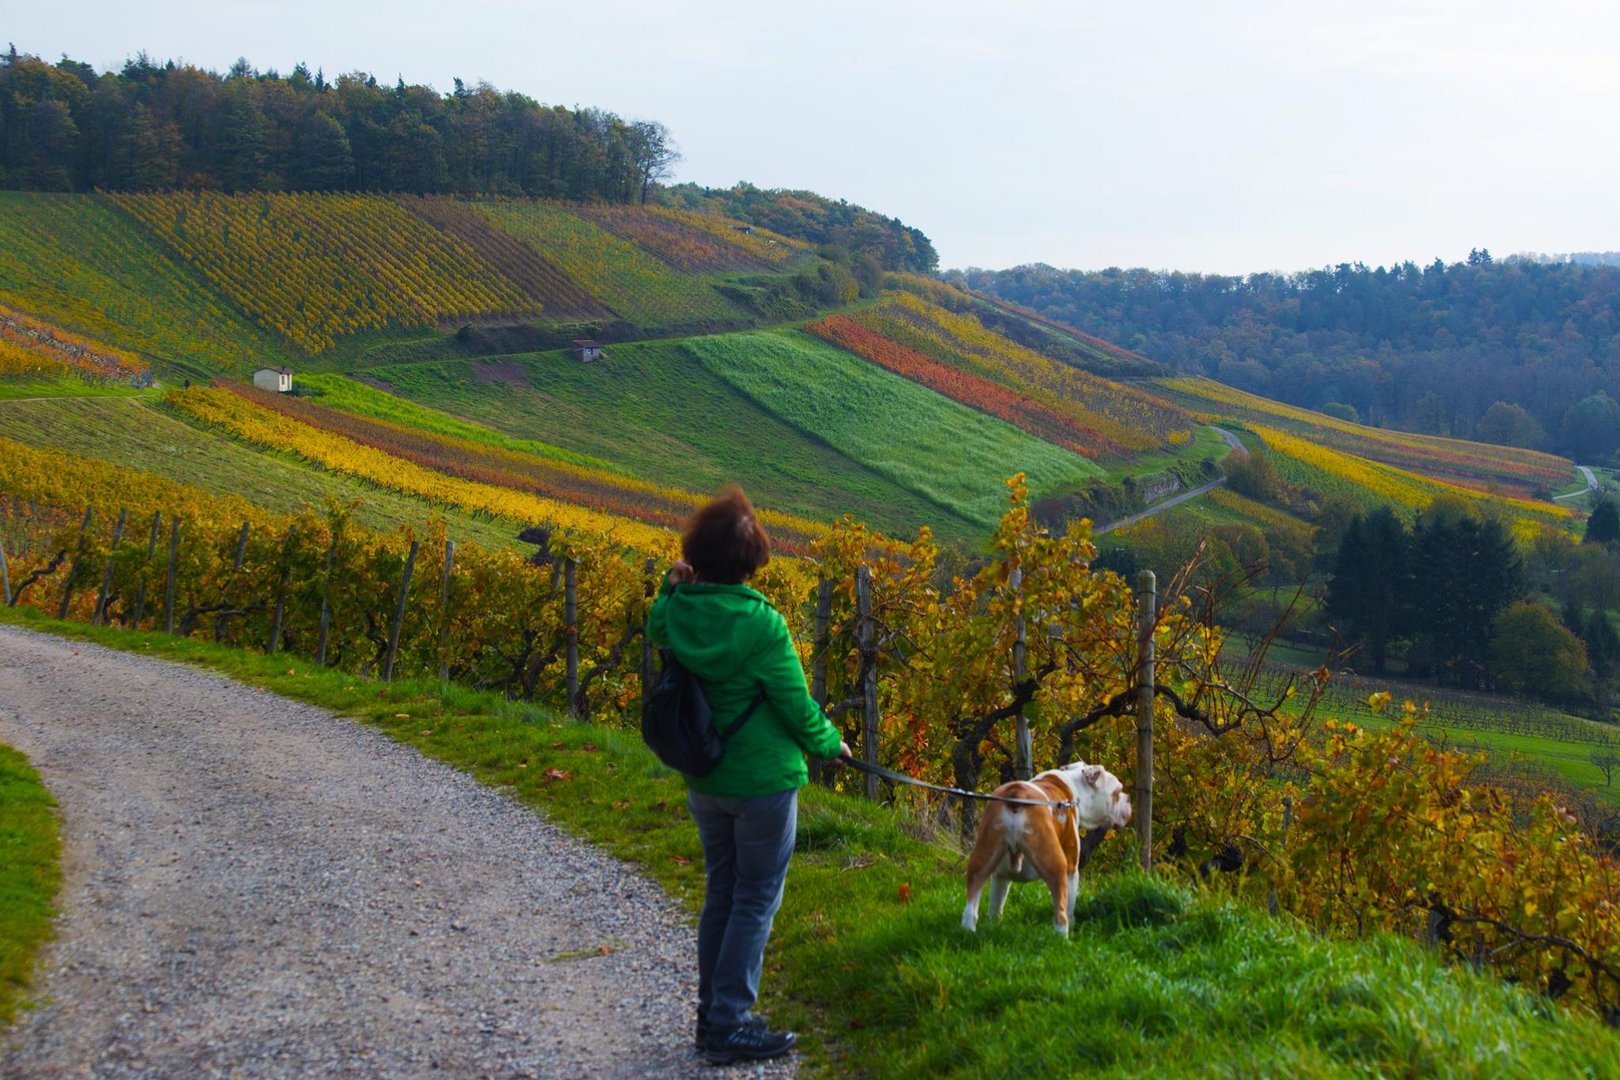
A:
959 259 1620 463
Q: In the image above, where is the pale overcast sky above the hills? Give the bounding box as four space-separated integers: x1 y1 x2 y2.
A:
12 0 1620 274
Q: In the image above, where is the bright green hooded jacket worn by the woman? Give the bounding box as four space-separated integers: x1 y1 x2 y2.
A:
646 578 842 798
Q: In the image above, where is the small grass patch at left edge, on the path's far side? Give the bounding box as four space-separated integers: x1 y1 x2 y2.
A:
0 745 62 1028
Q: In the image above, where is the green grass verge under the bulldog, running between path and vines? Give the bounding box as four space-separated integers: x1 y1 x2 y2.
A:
3 612 1620 1078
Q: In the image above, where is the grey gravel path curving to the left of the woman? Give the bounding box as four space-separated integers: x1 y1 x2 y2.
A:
0 627 792 1077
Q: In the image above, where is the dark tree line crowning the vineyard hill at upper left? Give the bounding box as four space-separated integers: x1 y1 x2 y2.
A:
0 45 940 272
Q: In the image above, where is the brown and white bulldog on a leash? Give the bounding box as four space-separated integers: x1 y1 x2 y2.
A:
962 761 1131 938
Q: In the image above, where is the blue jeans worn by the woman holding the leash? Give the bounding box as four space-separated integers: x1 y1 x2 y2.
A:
687 790 799 1028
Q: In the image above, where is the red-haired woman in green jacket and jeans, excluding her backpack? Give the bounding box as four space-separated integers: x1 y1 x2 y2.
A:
646 487 849 1064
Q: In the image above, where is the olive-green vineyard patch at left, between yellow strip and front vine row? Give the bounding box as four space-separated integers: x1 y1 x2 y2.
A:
0 398 518 547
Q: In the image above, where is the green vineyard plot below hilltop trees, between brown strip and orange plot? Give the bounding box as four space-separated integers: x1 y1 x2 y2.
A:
476 202 748 327
